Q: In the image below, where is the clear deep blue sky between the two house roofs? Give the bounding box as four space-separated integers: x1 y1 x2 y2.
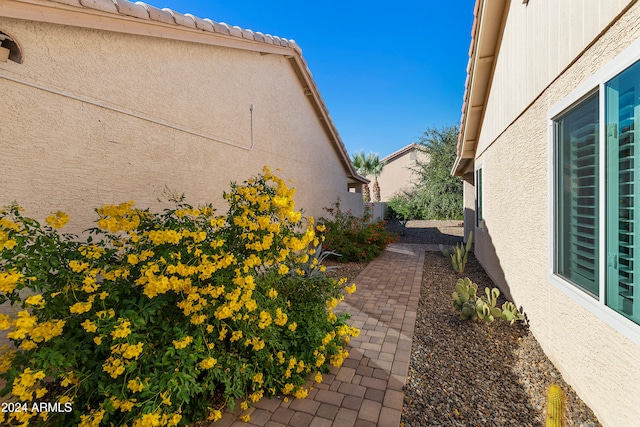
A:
154 0 475 157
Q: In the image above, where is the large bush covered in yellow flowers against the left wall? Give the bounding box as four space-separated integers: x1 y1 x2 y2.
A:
0 169 359 427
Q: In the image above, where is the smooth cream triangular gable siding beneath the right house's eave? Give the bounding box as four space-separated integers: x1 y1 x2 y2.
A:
478 0 633 152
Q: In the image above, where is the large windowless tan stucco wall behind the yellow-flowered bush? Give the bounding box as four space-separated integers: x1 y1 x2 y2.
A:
0 18 362 231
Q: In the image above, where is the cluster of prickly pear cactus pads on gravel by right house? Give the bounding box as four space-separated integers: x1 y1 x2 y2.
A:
451 277 525 325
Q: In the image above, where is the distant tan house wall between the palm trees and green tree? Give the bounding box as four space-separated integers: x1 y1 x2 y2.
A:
367 149 428 202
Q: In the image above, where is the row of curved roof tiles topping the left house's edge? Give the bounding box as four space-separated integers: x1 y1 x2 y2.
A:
51 0 302 55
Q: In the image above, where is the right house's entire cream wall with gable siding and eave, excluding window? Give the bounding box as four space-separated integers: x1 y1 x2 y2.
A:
454 0 640 427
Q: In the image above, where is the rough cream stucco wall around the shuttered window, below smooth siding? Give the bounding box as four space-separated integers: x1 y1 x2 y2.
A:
465 1 640 427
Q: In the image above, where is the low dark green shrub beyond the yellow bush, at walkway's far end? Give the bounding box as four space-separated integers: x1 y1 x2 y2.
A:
318 200 395 262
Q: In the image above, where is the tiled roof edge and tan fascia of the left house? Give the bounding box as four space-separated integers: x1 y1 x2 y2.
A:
0 0 368 183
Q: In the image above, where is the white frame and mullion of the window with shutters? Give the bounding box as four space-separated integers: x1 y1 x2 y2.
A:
547 35 640 345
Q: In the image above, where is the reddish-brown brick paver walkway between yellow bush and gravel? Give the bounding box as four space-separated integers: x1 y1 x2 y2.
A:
211 244 437 427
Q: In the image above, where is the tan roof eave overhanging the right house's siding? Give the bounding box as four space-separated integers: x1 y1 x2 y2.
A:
451 0 509 176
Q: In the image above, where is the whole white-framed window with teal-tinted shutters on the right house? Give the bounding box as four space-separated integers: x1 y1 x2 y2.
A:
550 56 640 332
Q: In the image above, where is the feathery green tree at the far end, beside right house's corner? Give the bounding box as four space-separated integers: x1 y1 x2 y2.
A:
413 126 463 219
